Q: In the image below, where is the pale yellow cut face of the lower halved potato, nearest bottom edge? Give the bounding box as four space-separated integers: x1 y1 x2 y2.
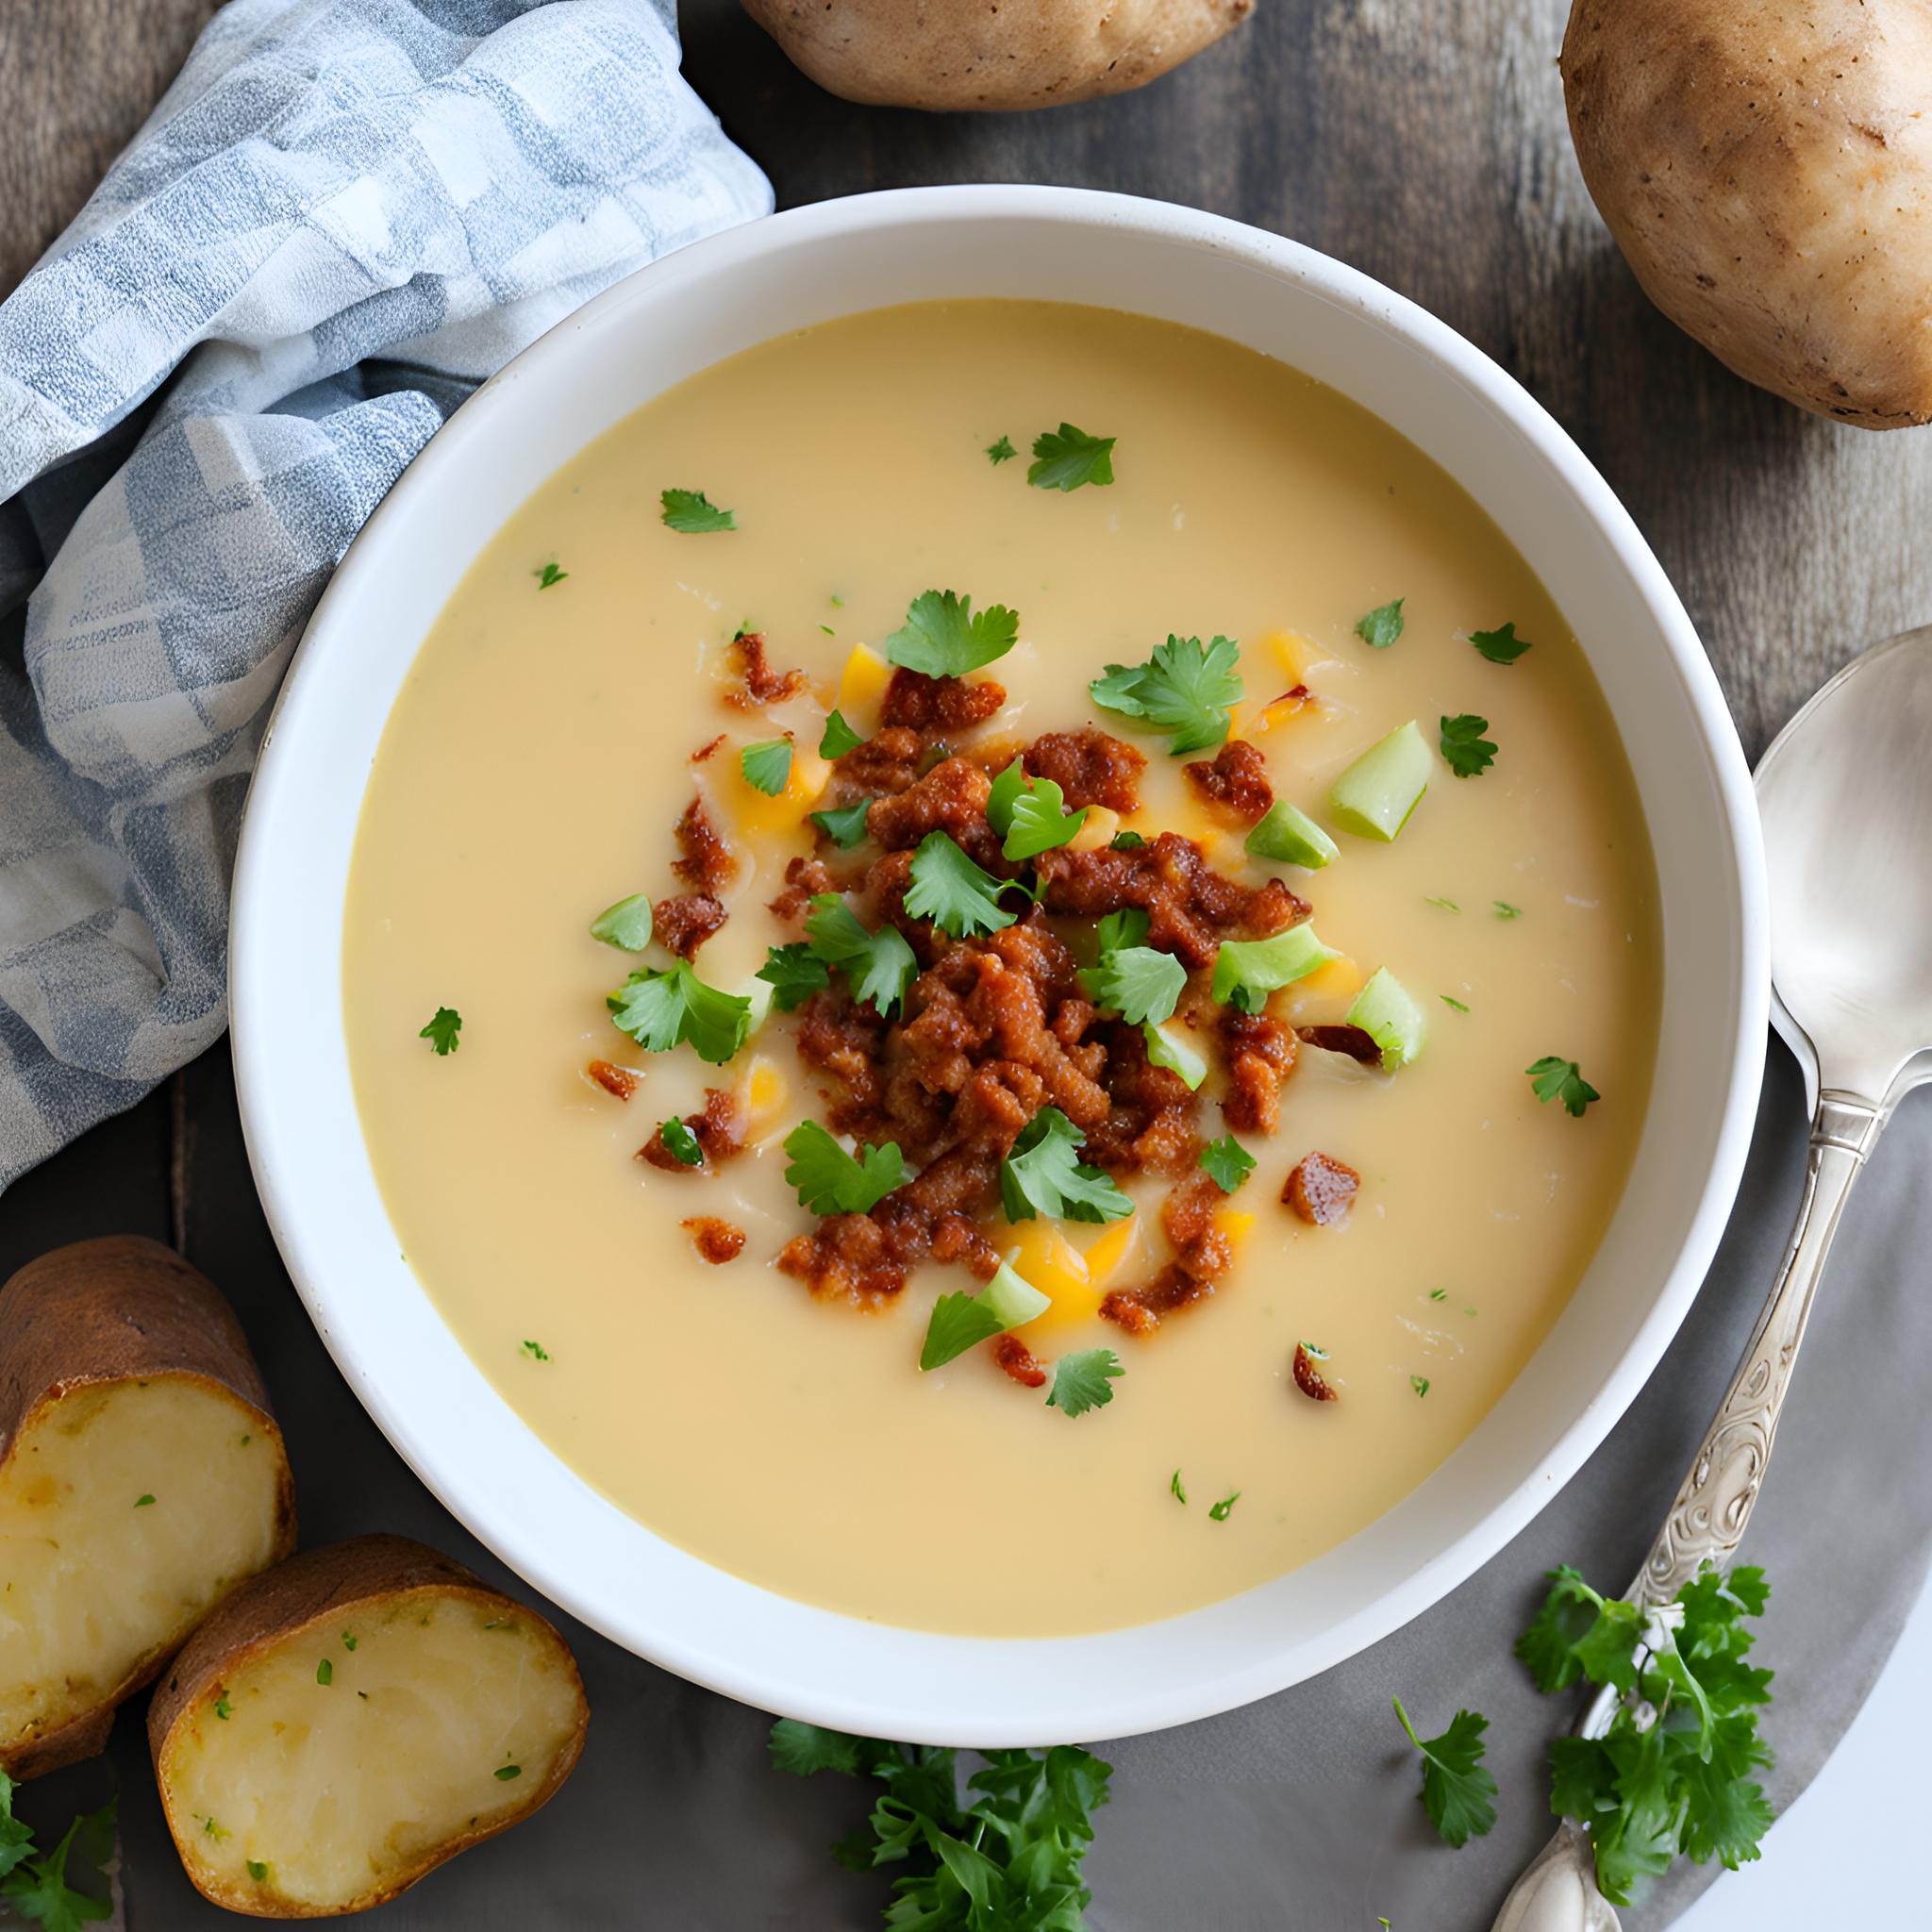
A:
162 1591 577 1907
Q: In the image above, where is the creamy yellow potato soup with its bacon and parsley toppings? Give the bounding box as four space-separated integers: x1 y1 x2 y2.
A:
344 301 1659 1637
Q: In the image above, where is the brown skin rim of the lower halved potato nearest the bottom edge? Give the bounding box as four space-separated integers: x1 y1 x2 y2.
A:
147 1536 591 1919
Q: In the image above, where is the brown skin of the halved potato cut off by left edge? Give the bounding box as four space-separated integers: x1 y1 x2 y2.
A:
0 1235 295 1779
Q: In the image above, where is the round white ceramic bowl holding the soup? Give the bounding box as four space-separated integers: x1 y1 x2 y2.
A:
230 188 1768 1744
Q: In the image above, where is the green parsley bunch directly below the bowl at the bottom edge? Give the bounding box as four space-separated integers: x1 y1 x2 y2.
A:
771 1718 1113 1932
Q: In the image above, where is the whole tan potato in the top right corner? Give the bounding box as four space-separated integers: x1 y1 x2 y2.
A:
1561 0 1932 429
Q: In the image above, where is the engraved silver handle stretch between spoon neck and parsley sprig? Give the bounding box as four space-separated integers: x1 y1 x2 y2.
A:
1631 1091 1886 1604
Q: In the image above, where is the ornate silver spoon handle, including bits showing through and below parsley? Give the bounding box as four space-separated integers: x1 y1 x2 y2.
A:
1493 1090 1890 1932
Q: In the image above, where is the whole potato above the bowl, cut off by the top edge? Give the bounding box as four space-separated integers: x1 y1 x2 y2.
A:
743 0 1254 112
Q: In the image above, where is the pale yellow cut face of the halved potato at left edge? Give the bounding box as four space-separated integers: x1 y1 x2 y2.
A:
0 1377 280 1746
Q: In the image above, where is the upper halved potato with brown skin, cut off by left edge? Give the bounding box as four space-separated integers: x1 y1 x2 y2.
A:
0 1237 295 1777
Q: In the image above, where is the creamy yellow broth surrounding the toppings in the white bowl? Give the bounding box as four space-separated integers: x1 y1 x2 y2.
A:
344 301 1659 1637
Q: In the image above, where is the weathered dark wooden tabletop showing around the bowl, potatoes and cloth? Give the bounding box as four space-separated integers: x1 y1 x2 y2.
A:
0 0 1932 1924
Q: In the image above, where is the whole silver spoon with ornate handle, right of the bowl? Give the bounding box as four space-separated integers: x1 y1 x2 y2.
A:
1495 626 1932 1932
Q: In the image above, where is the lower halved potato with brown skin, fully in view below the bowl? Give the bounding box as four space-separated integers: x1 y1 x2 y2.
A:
147 1536 590 1919
